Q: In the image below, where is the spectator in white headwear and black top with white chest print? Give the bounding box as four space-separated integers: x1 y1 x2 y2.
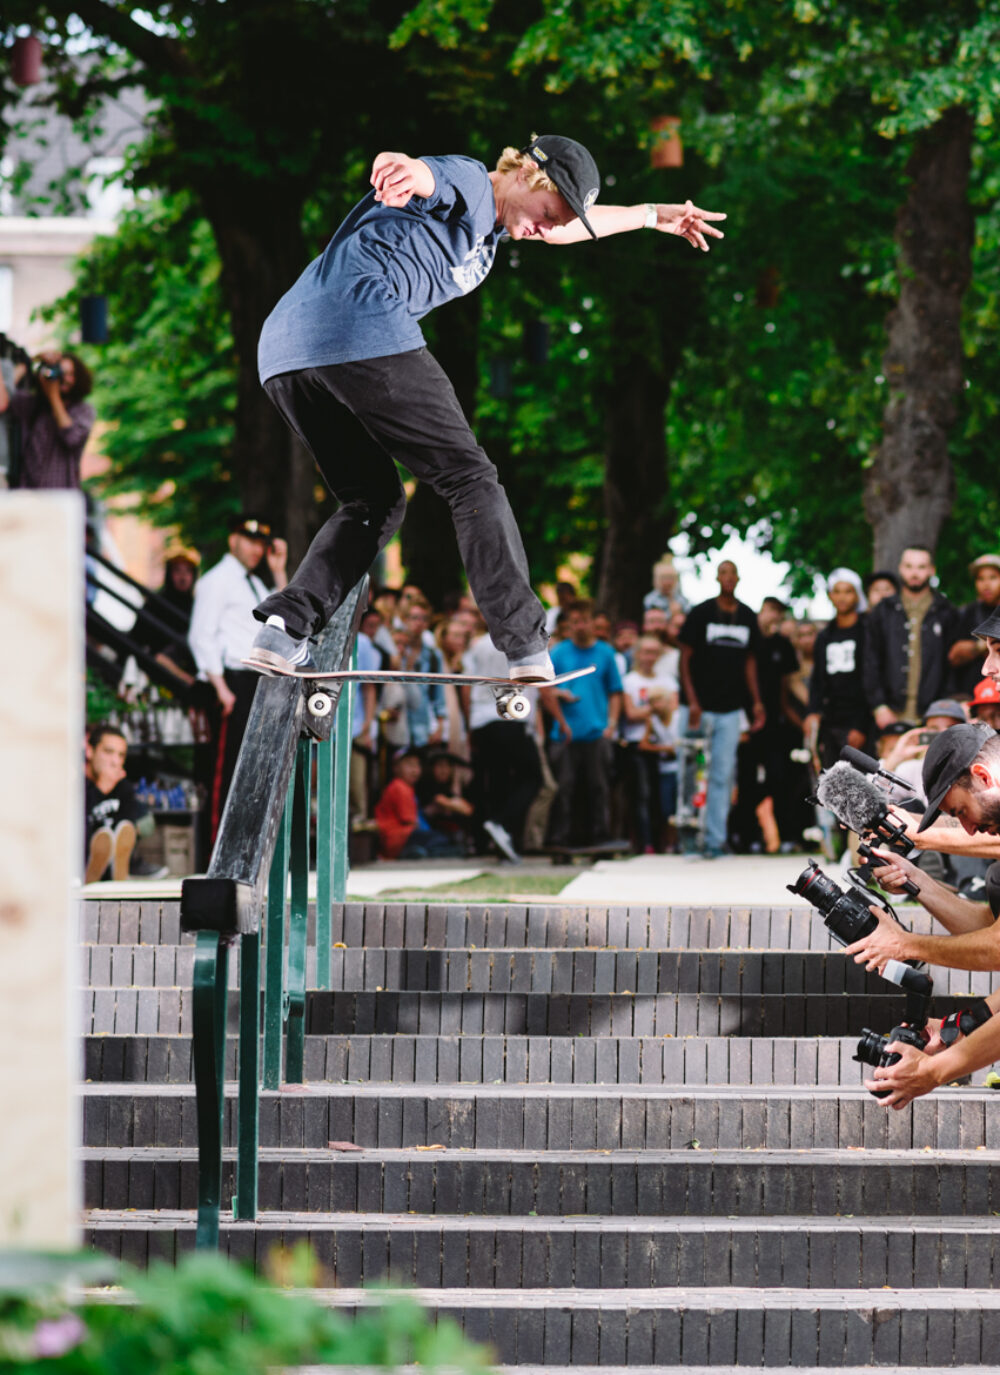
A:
806 568 873 769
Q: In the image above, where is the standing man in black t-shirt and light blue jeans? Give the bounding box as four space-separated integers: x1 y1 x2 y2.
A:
681 560 766 859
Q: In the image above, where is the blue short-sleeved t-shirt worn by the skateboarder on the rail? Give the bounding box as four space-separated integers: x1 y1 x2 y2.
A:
257 157 506 382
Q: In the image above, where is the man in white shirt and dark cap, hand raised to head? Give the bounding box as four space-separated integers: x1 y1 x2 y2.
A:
187 516 287 839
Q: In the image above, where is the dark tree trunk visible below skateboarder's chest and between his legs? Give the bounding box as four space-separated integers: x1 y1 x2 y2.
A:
400 294 483 608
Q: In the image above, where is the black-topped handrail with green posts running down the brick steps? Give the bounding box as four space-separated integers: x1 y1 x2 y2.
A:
180 578 367 1249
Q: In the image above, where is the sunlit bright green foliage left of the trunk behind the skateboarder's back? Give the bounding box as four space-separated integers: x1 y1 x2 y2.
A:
51 195 239 549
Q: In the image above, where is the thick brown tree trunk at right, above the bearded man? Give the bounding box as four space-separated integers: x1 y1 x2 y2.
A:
865 109 972 568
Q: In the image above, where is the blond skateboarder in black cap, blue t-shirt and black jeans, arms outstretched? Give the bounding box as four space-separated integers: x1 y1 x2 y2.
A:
252 135 725 679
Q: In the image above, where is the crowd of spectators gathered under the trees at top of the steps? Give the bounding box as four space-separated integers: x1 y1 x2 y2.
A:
82 495 1000 862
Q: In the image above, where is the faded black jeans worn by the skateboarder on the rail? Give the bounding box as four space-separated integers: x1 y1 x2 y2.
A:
254 348 549 659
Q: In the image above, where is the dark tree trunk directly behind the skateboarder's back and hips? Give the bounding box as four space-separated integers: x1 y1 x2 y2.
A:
204 199 320 571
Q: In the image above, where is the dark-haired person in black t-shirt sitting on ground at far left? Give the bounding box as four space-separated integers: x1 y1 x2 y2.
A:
84 726 153 883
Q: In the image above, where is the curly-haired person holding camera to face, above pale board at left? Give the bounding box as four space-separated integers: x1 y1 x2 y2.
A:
0 349 95 488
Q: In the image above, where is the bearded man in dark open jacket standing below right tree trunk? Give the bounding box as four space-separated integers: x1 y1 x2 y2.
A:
864 545 955 730
